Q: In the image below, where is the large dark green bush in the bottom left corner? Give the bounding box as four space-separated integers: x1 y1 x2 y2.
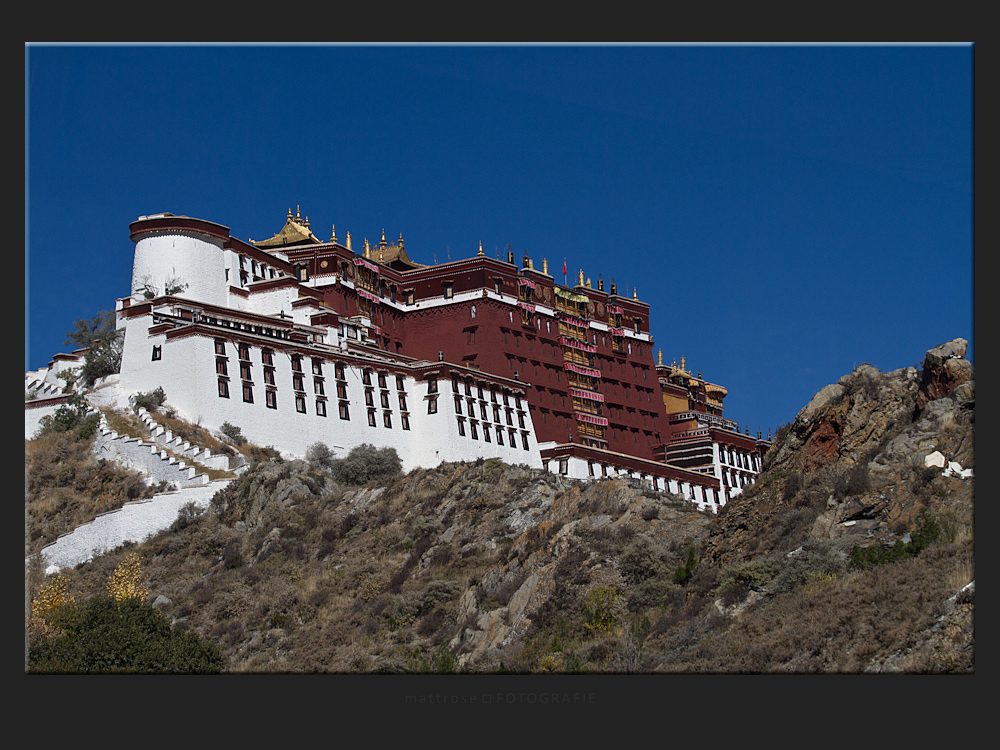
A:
28 595 225 674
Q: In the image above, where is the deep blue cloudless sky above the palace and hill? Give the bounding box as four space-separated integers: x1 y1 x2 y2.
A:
25 45 974 434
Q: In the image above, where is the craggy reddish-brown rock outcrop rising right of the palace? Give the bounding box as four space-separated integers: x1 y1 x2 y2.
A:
713 339 975 563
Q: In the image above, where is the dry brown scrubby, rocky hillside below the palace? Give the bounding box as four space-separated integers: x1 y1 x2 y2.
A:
23 340 975 673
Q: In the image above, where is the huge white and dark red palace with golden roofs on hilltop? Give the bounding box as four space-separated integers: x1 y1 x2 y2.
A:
25 210 770 510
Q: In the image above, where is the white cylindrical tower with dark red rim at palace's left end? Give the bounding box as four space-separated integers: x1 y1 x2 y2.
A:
129 213 229 305
